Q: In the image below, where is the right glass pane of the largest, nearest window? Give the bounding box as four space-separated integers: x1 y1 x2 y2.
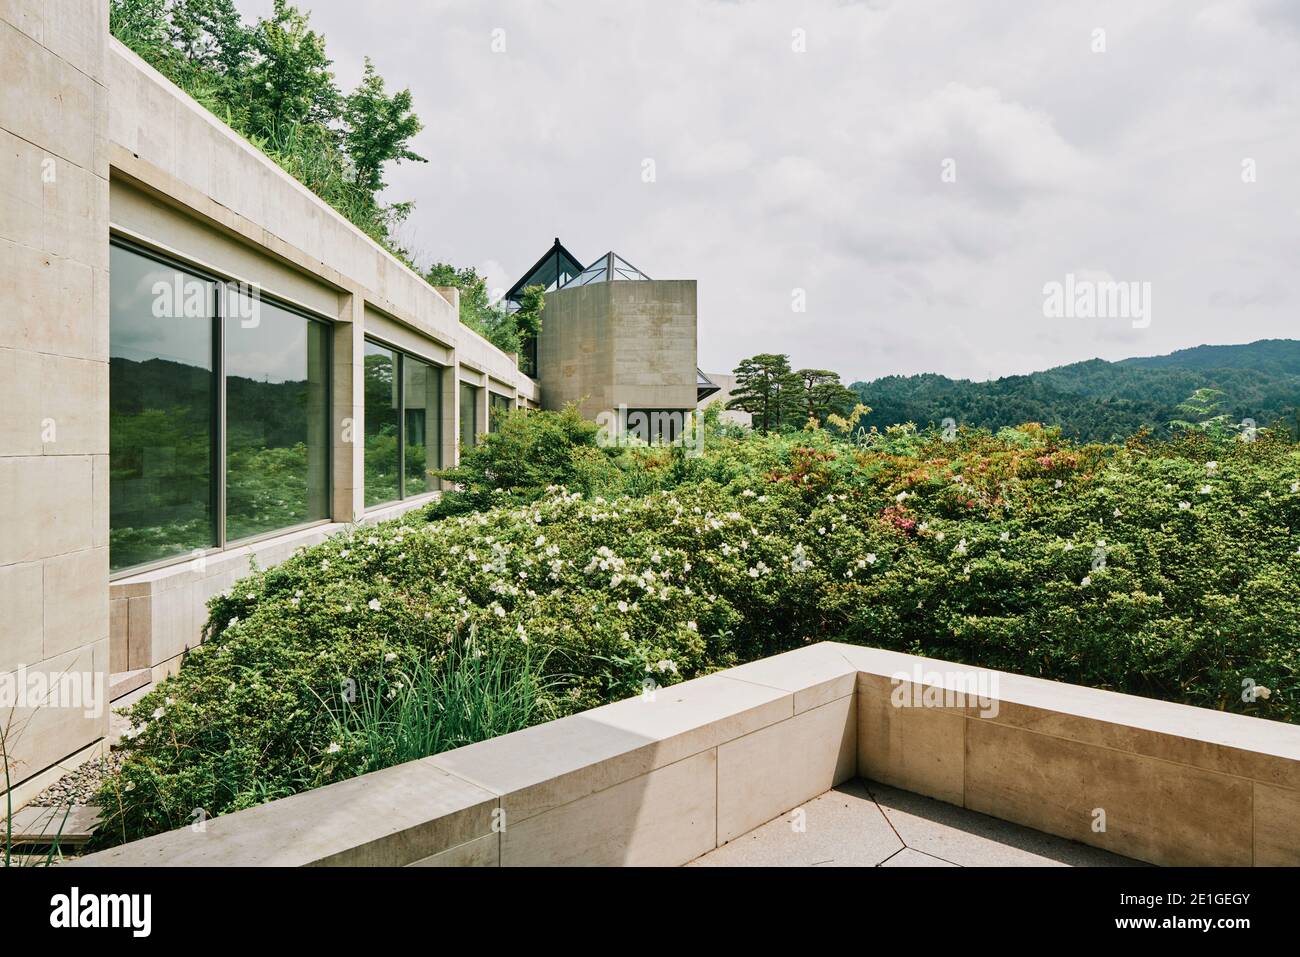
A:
225 287 329 541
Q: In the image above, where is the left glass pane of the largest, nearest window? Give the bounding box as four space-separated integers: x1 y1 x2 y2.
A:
108 246 217 568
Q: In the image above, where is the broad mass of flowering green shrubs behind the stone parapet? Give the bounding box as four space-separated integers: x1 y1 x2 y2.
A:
96 412 1300 840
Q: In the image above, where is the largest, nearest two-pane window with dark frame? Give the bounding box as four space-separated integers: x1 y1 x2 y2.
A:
109 243 330 571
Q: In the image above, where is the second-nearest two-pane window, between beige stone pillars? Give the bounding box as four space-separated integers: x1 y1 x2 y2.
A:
365 341 442 506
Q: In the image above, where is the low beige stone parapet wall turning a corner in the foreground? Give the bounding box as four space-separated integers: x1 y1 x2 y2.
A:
78 642 1300 866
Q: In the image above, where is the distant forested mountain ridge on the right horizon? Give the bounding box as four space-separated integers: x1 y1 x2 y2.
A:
850 339 1300 442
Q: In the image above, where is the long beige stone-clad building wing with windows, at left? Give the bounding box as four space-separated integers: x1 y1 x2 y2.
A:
0 0 542 804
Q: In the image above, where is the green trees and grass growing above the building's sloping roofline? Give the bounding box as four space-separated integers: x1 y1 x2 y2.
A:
109 0 527 354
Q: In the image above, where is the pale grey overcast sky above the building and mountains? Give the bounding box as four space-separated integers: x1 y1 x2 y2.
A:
239 0 1300 381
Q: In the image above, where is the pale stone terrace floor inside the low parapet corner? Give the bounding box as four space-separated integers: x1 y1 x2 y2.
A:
689 780 1143 867
